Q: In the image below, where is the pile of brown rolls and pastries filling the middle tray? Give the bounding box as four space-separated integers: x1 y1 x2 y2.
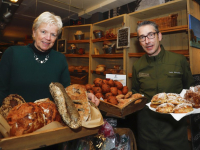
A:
85 78 143 108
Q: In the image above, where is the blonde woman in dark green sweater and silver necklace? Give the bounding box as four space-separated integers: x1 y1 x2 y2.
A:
0 12 99 105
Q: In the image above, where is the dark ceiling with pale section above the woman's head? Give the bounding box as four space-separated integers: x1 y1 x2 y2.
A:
0 0 136 41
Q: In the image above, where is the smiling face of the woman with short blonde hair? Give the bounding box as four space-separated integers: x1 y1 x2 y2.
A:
33 23 58 52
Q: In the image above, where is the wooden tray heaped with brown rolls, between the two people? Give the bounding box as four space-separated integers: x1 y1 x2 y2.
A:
85 78 147 118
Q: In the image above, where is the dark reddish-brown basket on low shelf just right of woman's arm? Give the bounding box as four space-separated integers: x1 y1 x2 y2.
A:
70 72 88 85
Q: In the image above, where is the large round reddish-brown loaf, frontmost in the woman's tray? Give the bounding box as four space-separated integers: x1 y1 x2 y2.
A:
6 102 45 136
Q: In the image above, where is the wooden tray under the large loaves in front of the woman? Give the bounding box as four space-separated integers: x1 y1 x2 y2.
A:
0 127 99 150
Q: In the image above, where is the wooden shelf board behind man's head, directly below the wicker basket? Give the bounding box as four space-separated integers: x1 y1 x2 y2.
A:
130 25 188 38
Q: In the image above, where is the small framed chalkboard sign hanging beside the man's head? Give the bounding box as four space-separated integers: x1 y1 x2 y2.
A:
117 27 130 48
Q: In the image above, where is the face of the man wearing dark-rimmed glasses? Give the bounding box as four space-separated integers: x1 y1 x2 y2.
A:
138 25 162 57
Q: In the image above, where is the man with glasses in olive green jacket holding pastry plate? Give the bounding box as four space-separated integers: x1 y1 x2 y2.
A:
132 21 194 150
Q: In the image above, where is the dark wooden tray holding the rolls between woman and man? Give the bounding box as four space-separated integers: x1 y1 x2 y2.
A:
99 97 147 118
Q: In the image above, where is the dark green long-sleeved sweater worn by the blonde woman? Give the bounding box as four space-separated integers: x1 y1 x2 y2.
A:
0 45 70 102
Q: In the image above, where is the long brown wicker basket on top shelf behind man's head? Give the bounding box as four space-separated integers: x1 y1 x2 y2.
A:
137 14 178 29
